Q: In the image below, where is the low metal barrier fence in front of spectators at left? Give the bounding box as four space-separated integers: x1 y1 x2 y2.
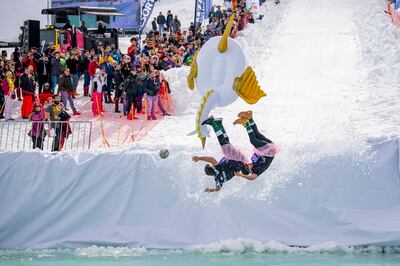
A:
0 121 92 151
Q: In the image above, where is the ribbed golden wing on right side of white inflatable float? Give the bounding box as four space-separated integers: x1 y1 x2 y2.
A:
233 66 267 104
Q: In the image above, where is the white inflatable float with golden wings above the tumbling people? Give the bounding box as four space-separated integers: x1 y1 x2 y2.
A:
187 15 266 149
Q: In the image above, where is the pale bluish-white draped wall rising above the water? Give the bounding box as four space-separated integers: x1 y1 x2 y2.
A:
0 139 400 248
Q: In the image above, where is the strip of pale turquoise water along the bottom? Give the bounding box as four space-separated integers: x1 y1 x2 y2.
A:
0 250 400 266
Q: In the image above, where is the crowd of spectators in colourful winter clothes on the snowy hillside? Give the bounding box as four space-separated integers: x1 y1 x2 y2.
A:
0 0 262 150
